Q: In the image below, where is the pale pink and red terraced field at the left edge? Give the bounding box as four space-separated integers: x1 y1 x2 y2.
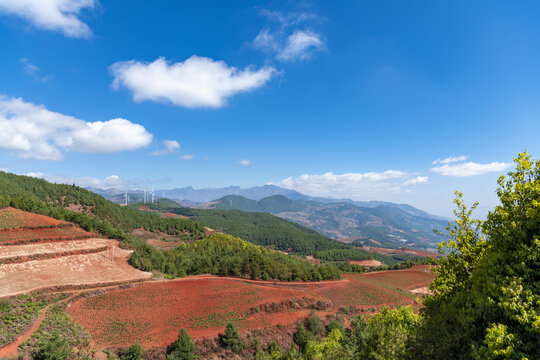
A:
0 208 151 298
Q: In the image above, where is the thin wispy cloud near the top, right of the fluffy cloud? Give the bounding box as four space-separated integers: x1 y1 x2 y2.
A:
253 10 324 61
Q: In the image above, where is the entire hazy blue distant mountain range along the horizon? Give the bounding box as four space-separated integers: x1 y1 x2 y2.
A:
89 185 448 249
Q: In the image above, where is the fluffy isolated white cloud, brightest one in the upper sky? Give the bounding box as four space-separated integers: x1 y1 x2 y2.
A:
110 55 276 108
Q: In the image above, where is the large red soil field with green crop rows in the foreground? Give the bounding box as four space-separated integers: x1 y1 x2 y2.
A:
68 269 433 348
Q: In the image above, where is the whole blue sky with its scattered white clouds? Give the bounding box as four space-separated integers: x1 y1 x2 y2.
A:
0 0 540 215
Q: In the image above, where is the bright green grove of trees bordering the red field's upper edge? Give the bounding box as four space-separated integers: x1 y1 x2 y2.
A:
130 234 363 281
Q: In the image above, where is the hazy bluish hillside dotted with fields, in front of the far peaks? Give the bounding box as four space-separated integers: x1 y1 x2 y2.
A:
196 195 447 249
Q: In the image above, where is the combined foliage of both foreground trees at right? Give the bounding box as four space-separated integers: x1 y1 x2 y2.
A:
413 153 540 359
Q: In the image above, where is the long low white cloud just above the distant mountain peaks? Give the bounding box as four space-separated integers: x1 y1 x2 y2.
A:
274 170 428 199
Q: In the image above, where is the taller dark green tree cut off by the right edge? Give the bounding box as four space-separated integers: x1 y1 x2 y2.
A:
464 153 540 359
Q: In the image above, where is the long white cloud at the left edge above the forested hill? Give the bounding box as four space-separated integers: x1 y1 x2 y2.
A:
0 95 152 160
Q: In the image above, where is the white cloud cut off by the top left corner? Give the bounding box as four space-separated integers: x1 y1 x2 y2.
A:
0 0 98 38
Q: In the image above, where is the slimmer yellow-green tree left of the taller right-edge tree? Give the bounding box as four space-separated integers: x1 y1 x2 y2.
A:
413 191 489 360
